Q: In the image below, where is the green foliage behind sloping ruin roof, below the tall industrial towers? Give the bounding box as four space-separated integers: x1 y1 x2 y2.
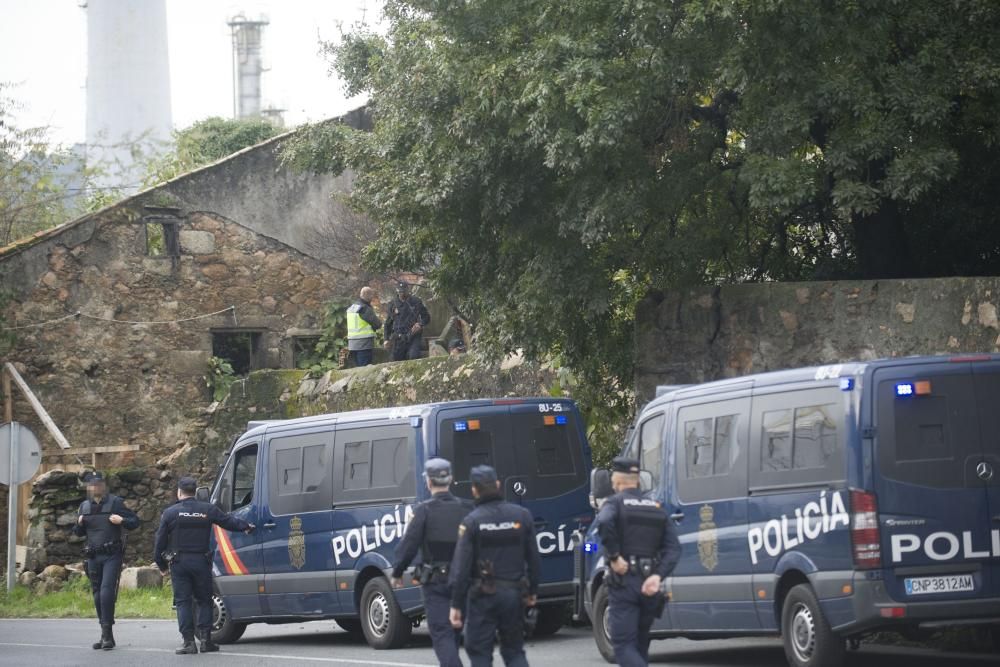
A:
145 117 281 186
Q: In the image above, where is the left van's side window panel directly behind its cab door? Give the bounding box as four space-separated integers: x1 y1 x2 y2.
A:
268 432 333 516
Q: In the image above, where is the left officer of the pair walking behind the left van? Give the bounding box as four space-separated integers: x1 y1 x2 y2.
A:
392 459 472 667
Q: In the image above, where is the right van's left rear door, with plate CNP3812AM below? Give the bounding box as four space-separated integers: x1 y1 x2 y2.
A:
872 362 988 602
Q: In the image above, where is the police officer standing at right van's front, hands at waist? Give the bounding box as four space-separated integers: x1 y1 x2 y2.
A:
597 457 681 667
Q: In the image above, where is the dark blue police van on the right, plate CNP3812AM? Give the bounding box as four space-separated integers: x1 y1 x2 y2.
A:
575 355 1000 666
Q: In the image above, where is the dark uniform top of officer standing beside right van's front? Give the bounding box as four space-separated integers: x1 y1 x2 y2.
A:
597 489 681 578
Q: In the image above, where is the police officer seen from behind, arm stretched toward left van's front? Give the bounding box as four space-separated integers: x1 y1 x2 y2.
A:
153 477 254 655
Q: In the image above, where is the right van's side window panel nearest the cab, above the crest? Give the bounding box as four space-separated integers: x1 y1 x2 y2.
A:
674 398 750 503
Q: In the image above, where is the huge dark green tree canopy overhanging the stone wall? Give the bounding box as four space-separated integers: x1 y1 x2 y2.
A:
286 0 1000 380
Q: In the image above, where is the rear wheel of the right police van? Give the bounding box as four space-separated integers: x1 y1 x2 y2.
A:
781 584 845 667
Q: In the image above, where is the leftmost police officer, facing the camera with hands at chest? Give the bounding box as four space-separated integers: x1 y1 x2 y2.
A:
73 472 139 651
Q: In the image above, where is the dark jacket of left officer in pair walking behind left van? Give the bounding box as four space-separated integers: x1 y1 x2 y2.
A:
392 491 472 579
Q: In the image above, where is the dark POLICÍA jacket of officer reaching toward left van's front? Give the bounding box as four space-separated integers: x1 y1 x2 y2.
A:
153 498 250 570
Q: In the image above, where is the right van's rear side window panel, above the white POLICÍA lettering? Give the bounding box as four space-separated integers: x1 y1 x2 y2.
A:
750 387 847 490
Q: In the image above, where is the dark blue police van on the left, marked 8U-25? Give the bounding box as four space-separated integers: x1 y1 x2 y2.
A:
205 398 593 649
